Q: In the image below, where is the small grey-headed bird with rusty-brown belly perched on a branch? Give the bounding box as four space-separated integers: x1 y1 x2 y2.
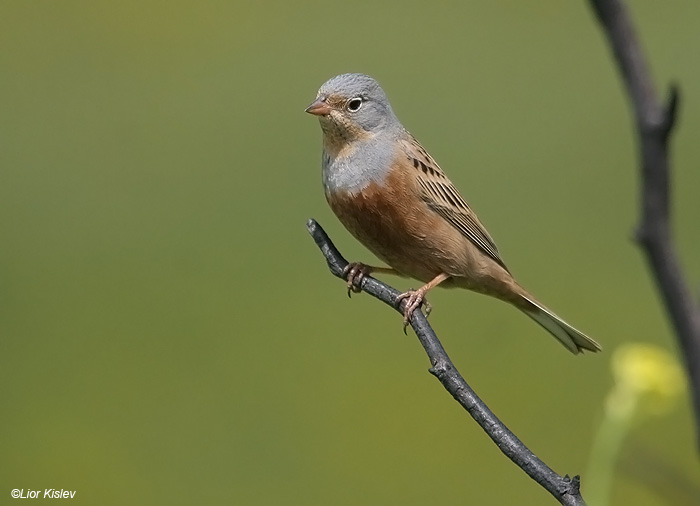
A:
305 73 601 354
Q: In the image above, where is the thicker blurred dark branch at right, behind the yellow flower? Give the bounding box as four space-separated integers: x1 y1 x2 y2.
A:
591 0 700 442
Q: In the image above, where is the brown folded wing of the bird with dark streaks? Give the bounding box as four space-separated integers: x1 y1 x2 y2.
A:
401 134 508 270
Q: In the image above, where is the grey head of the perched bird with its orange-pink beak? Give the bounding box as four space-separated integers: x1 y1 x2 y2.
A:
306 74 403 142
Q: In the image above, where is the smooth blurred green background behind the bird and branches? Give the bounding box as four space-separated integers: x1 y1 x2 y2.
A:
0 0 700 505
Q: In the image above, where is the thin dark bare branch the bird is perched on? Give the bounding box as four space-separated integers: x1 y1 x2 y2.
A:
306 220 585 506
